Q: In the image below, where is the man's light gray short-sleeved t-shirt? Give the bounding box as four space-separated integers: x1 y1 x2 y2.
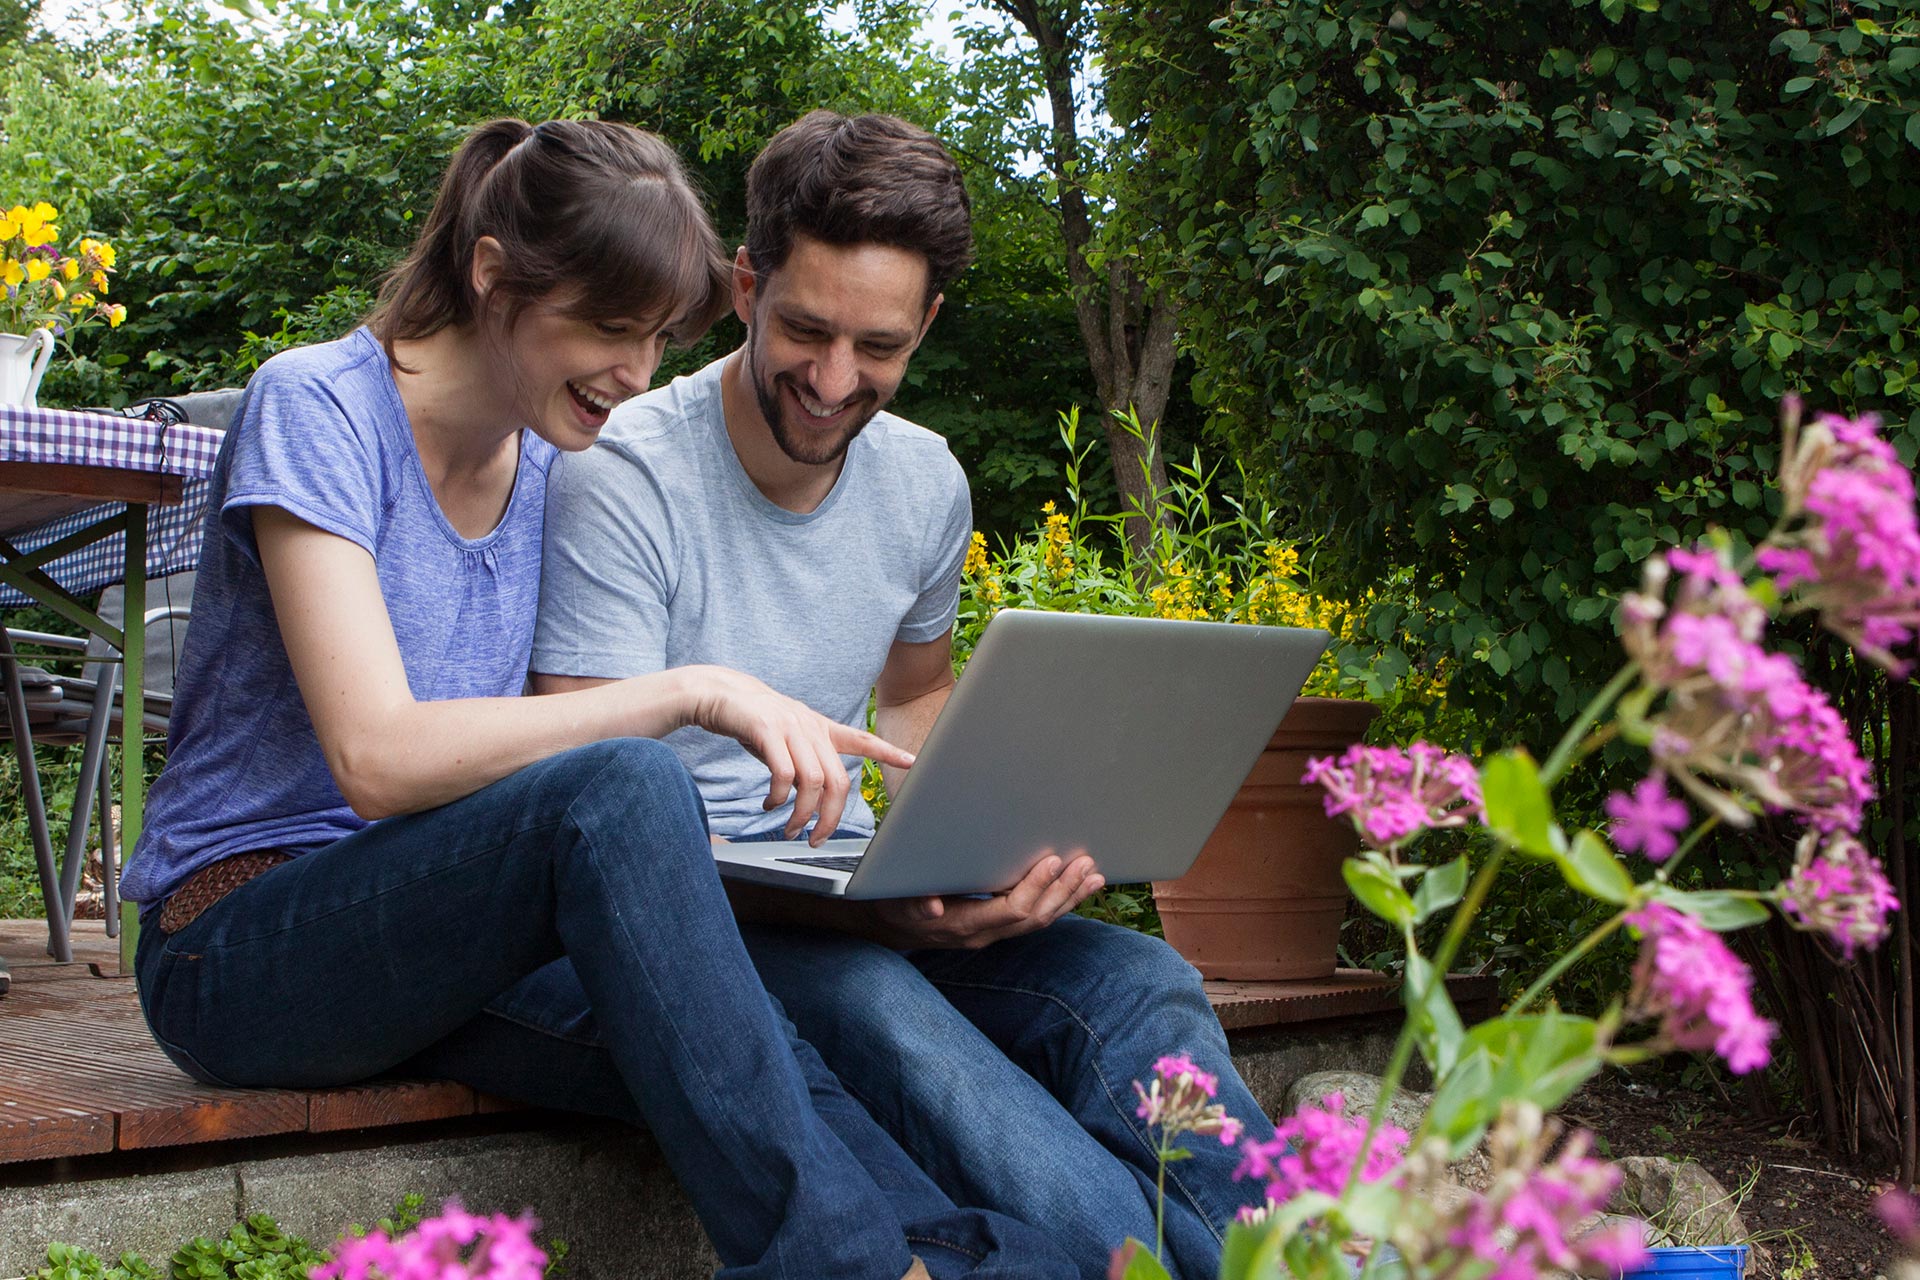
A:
532 359 973 837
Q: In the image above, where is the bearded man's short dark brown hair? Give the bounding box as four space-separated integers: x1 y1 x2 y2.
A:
747 111 973 303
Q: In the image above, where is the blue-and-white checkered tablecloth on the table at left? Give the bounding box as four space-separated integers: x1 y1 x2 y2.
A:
0 405 227 608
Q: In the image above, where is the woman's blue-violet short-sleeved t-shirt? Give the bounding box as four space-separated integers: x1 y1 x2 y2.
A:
121 328 555 904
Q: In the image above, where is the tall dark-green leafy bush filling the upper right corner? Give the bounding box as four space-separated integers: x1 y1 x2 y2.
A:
1114 0 1920 737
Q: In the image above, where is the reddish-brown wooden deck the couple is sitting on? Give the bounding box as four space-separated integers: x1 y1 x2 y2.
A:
0 919 1494 1163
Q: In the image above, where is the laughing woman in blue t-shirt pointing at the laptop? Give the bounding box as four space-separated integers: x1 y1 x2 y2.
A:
125 121 1073 1280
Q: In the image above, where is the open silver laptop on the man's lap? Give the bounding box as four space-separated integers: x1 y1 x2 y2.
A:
714 608 1329 898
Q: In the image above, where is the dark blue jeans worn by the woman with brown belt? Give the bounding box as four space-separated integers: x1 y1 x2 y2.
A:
138 739 1077 1280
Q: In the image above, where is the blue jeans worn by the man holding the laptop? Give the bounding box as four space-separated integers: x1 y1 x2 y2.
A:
741 833 1273 1280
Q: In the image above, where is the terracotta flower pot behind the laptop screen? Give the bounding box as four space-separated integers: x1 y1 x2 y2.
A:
1154 699 1377 981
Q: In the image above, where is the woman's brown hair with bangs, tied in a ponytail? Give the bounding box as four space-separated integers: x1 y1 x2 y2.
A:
367 119 730 367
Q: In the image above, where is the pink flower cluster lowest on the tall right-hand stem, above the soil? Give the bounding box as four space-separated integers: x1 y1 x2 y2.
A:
1626 902 1774 1075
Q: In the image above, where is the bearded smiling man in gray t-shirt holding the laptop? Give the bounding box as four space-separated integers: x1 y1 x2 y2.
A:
534 111 1261 1276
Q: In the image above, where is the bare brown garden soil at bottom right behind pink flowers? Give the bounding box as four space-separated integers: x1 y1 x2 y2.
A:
1561 1073 1897 1280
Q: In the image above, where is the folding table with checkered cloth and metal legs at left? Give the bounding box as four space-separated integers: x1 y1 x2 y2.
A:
0 405 225 971
